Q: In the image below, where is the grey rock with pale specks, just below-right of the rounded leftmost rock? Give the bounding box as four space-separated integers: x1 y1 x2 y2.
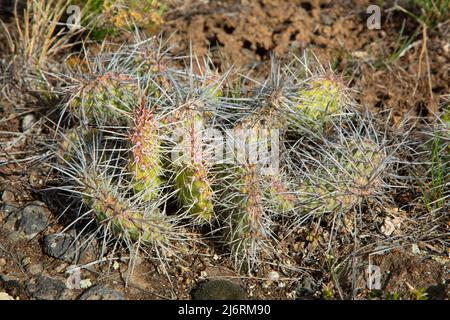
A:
43 234 77 262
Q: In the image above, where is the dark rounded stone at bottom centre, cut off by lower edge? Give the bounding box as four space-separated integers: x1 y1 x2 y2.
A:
193 279 246 300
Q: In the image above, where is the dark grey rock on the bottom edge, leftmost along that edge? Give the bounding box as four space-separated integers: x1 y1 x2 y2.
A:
26 276 67 300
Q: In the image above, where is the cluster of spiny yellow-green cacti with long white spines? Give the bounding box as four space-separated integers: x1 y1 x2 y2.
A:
53 37 398 271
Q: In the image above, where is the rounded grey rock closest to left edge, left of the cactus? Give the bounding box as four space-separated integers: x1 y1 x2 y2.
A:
16 201 49 239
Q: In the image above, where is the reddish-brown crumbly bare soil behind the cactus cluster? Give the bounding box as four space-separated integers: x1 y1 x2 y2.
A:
163 0 450 117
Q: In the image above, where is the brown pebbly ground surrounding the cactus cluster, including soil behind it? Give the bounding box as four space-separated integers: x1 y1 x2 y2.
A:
0 0 450 299
